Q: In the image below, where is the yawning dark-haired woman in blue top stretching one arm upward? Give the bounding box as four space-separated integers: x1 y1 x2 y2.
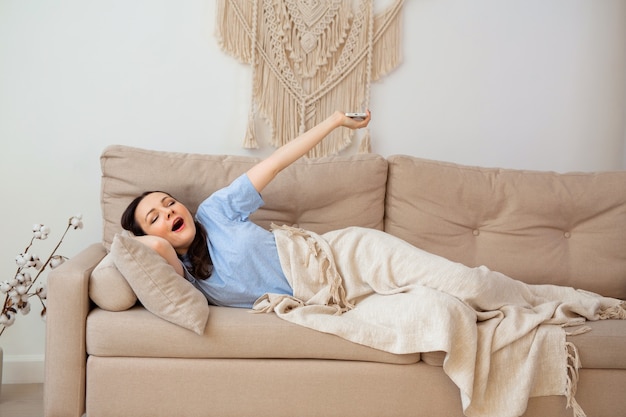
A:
122 111 371 308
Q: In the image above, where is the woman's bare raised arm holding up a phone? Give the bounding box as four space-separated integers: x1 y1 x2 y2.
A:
247 111 371 192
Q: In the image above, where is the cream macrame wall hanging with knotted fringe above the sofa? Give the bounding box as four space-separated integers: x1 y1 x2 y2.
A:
217 0 404 157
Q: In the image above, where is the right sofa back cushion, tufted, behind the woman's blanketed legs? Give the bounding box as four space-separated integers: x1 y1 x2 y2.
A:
385 156 626 299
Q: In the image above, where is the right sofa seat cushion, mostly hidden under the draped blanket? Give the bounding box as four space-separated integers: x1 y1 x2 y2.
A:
422 320 626 369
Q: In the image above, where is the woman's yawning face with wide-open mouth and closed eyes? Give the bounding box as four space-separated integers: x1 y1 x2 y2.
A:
135 192 196 255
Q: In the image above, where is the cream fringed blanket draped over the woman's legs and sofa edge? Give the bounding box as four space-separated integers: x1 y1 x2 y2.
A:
255 227 626 417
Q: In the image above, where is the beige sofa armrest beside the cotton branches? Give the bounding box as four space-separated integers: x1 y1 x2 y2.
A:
44 243 106 417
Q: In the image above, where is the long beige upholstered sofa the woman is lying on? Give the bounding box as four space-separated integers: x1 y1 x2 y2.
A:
45 146 626 417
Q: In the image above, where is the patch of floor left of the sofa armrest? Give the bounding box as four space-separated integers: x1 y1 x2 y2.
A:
0 384 43 417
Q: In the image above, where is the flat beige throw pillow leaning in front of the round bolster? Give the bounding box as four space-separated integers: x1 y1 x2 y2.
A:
111 234 209 334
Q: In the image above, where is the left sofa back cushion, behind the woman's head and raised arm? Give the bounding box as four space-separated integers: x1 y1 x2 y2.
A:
100 145 387 249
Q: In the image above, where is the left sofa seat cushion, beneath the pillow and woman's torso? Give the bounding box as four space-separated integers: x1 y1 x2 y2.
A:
86 306 420 364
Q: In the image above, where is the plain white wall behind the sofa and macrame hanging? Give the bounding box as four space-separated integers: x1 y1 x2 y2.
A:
0 0 626 382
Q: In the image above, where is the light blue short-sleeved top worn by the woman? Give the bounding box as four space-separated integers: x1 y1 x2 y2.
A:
186 174 293 308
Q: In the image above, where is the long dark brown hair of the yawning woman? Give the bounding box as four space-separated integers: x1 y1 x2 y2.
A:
121 191 213 279
